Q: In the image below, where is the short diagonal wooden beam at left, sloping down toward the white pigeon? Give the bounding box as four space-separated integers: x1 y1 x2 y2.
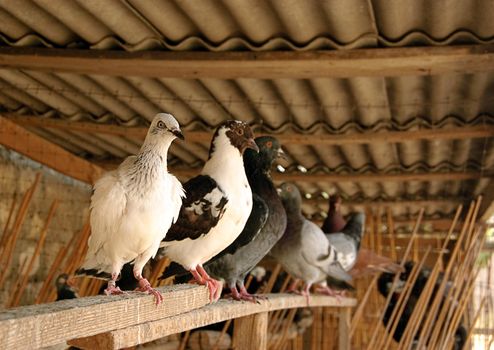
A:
0 116 104 184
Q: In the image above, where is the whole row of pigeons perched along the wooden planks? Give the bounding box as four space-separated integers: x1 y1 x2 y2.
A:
74 113 395 304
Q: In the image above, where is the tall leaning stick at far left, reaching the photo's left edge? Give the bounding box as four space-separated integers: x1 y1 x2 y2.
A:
0 173 41 285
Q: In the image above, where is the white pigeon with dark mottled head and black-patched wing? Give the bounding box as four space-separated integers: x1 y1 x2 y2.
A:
160 120 259 301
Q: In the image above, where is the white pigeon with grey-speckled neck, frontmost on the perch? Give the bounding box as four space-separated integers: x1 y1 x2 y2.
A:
76 113 184 304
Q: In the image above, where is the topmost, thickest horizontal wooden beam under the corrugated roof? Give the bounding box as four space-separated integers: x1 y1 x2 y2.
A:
0 44 494 79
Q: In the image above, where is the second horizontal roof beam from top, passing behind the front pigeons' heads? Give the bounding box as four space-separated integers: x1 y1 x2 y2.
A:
3 113 494 146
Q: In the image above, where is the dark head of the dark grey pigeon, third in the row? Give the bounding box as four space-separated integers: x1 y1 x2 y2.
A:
244 136 286 171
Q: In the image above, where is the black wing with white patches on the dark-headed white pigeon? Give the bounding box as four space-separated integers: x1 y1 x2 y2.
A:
162 175 228 242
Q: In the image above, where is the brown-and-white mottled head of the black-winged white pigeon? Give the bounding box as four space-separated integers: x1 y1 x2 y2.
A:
209 120 259 158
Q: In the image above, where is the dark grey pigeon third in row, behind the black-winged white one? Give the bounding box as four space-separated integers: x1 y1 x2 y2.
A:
205 136 287 301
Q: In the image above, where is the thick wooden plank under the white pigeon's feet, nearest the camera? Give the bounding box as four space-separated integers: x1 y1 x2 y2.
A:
0 285 209 349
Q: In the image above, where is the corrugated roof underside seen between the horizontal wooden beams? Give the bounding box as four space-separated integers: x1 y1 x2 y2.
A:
0 0 494 227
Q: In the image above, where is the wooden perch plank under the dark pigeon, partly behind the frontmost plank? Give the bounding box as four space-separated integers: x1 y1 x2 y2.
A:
70 294 356 349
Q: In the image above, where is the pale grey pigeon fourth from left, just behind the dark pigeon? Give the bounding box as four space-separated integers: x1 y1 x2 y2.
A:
271 183 351 298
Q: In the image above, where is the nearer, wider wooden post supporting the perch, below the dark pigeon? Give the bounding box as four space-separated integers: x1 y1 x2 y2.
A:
233 312 268 350
